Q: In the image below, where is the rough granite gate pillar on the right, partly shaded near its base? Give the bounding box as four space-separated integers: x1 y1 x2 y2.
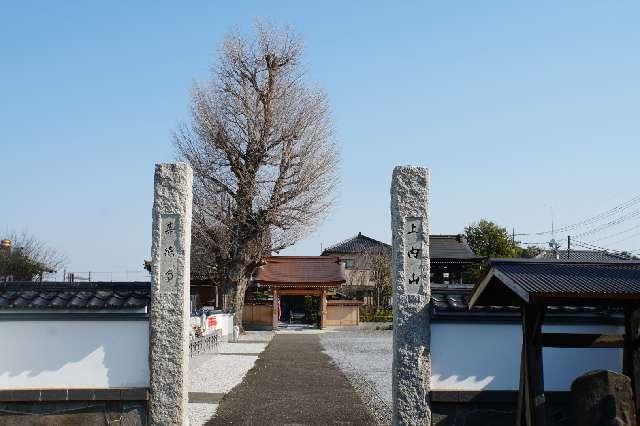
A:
391 166 431 425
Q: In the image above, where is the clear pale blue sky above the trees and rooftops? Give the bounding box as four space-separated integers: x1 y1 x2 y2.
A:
0 1 640 272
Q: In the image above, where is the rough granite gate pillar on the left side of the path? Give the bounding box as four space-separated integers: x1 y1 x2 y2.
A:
149 163 193 425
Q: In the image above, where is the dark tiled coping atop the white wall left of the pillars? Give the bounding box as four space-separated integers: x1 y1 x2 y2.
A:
0 282 150 310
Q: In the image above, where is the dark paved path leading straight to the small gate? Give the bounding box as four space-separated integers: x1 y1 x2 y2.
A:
207 332 376 425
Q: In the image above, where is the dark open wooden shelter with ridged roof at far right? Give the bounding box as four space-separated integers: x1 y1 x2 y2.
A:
469 259 640 426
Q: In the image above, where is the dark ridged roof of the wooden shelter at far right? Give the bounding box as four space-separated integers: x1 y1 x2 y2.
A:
470 259 640 306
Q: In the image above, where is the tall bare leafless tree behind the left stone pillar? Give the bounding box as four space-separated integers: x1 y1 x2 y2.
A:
175 23 338 326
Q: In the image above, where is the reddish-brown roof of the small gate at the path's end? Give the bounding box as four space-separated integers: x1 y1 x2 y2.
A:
254 256 346 287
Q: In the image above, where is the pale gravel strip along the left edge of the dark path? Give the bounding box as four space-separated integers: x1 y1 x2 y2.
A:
189 331 273 426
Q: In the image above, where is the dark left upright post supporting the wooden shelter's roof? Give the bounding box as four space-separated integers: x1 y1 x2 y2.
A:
522 304 546 426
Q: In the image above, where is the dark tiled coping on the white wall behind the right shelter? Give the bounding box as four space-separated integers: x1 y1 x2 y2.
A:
431 283 621 323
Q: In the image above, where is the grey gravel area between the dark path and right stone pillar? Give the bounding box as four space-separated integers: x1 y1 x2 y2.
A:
320 325 393 425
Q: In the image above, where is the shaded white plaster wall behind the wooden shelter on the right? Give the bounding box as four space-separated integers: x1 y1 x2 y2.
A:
431 323 624 391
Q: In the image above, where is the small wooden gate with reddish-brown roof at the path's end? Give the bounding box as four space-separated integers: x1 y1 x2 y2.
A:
254 256 346 330
